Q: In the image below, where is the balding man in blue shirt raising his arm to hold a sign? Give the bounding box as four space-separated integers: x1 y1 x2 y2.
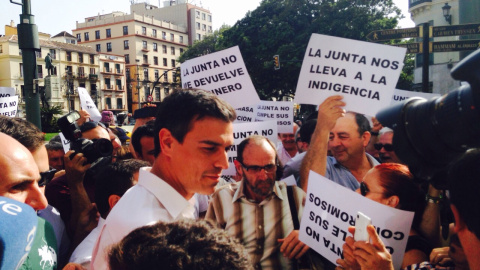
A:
300 96 379 191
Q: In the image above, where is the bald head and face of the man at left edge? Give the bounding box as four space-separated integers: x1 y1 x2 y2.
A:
0 133 47 211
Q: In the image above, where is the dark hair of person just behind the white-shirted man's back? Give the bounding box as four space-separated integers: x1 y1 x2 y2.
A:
95 159 150 218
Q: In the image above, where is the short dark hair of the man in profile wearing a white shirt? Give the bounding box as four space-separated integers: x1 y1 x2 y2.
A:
154 89 236 157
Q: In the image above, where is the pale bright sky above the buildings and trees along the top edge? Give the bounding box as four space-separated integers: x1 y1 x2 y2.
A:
0 0 414 35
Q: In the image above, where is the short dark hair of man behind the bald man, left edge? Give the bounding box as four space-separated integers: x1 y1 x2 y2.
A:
0 115 45 152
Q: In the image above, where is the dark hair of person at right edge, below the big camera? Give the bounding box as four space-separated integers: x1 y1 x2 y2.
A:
448 149 480 239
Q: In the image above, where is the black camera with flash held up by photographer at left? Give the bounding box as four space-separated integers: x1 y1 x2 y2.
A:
57 111 113 167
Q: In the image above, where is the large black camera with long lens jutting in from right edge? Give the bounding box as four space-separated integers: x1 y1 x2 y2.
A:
376 50 480 189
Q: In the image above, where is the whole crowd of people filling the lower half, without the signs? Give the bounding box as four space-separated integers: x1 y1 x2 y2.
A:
0 90 480 270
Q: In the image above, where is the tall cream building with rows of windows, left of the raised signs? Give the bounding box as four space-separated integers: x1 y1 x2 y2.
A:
73 8 188 112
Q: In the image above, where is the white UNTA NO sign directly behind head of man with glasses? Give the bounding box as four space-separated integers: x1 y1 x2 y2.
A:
222 121 278 175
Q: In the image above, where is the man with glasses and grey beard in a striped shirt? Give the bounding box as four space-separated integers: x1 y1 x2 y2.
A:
205 135 308 269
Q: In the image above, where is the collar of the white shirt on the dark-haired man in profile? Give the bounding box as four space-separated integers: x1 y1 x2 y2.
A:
137 167 195 219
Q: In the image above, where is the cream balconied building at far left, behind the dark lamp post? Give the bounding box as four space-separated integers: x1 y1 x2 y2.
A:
0 26 99 117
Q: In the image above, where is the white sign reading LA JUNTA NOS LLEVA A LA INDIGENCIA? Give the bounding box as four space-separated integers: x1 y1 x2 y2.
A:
294 34 406 115
